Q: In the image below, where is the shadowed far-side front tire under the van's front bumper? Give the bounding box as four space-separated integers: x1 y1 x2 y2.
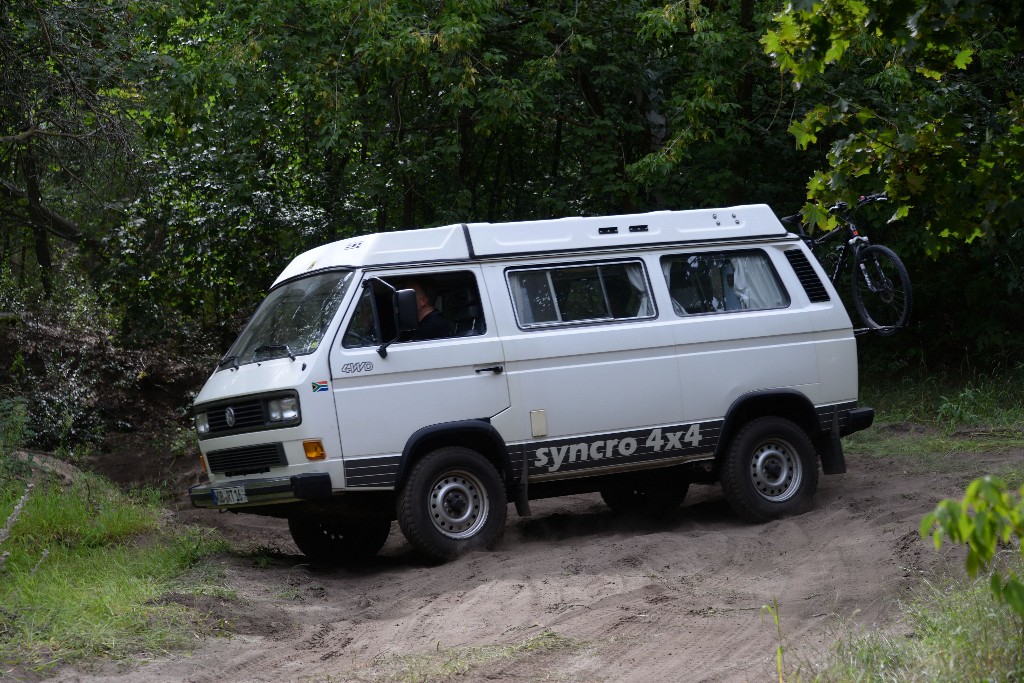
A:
288 515 391 563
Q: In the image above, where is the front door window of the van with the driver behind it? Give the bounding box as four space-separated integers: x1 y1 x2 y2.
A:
341 271 487 348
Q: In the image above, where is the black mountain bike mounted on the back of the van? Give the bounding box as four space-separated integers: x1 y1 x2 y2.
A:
781 193 912 336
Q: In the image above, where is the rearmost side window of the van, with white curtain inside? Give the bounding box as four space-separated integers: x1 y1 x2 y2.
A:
662 251 790 315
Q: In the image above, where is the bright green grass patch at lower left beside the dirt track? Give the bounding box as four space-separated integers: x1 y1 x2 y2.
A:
0 466 228 677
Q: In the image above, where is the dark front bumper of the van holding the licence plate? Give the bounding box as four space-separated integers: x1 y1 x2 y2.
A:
188 472 332 510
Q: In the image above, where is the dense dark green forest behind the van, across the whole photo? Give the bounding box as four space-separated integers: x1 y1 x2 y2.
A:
0 0 1024 456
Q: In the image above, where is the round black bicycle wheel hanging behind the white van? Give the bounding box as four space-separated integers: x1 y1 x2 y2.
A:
853 245 911 336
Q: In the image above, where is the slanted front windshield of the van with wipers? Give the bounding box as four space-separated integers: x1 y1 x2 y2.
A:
218 270 352 370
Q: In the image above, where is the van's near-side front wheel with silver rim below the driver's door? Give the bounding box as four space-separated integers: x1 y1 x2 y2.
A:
397 446 508 561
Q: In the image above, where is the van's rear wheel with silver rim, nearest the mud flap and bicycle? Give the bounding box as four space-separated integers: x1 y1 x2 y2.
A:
722 417 818 522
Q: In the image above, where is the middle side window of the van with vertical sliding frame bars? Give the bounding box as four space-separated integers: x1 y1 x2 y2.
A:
508 261 654 328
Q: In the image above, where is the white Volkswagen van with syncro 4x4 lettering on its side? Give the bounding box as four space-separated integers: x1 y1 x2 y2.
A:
189 205 873 561
